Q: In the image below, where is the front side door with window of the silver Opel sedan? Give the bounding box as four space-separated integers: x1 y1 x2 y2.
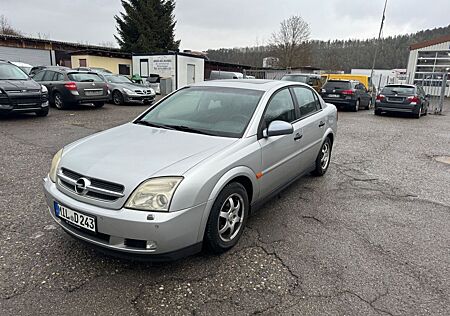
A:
259 88 303 197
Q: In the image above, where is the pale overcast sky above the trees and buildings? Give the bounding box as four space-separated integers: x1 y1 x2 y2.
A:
0 0 450 50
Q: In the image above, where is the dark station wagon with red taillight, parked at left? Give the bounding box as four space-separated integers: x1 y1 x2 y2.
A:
33 68 110 110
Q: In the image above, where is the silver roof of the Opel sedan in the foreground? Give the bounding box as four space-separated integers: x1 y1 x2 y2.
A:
192 79 302 91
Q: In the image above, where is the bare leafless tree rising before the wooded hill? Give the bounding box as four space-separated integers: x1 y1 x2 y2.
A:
270 15 311 67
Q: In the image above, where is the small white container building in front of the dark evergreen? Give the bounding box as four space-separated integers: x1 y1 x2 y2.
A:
131 52 205 90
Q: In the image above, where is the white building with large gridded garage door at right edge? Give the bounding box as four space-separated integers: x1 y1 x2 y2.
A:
406 34 450 96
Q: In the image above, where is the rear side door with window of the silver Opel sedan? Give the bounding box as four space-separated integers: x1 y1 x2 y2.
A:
292 86 326 172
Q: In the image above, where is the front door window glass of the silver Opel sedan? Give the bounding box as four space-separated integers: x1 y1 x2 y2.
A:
264 89 296 127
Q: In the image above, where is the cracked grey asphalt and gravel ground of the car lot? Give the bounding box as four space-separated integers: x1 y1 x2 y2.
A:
0 100 450 316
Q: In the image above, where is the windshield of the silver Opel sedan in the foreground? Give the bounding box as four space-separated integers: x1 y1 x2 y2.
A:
136 87 263 138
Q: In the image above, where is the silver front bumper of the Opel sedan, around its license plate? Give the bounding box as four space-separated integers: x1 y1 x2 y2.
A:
44 177 206 257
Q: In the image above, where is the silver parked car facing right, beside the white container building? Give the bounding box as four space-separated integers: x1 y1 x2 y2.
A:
99 74 156 105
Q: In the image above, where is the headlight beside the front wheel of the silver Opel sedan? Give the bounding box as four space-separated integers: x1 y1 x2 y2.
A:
125 177 183 212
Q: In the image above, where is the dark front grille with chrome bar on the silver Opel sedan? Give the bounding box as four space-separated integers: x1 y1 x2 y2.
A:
59 168 125 201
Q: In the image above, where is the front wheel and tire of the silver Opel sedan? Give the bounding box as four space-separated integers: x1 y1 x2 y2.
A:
204 182 249 254
